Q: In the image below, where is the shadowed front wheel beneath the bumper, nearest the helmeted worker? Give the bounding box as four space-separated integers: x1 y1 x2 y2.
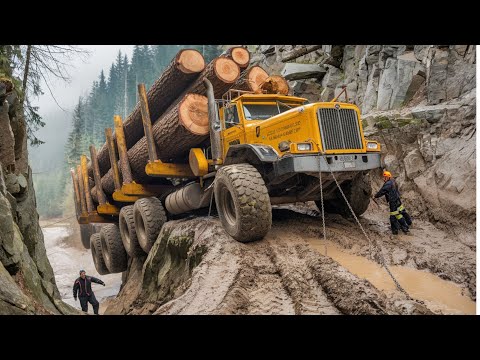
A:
315 173 372 218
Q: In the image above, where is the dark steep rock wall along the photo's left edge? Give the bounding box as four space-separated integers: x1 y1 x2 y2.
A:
0 78 77 314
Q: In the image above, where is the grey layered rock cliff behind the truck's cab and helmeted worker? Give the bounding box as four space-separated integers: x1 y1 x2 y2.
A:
249 45 476 245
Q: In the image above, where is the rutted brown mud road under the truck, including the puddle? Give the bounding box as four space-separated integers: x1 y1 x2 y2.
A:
106 201 476 315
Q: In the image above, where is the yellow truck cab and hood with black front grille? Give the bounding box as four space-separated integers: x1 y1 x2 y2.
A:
219 94 380 163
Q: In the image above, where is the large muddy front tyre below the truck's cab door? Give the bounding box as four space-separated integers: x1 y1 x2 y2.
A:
214 164 272 242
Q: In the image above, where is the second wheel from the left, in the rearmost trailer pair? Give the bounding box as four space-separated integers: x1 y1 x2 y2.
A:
100 224 128 274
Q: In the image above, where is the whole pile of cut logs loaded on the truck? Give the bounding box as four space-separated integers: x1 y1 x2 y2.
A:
91 47 289 200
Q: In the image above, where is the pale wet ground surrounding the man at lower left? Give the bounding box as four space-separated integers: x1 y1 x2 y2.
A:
42 223 122 313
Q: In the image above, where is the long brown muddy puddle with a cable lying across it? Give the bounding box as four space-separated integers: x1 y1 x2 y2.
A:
306 238 476 314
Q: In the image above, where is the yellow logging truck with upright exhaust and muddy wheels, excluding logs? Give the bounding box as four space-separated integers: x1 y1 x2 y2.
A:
73 80 381 274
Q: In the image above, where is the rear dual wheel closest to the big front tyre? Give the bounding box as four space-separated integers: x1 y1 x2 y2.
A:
133 197 167 254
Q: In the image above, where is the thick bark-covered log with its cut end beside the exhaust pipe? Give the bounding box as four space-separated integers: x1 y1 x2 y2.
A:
97 94 208 194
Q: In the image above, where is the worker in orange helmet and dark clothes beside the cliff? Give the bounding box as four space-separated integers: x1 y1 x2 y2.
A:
375 170 412 235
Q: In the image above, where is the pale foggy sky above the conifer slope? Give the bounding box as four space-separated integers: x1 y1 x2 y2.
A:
33 45 133 116
